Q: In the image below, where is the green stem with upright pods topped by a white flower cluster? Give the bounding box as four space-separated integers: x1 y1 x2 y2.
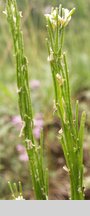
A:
46 6 85 200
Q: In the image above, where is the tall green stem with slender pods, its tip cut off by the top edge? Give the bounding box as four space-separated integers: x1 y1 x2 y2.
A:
5 0 48 200
